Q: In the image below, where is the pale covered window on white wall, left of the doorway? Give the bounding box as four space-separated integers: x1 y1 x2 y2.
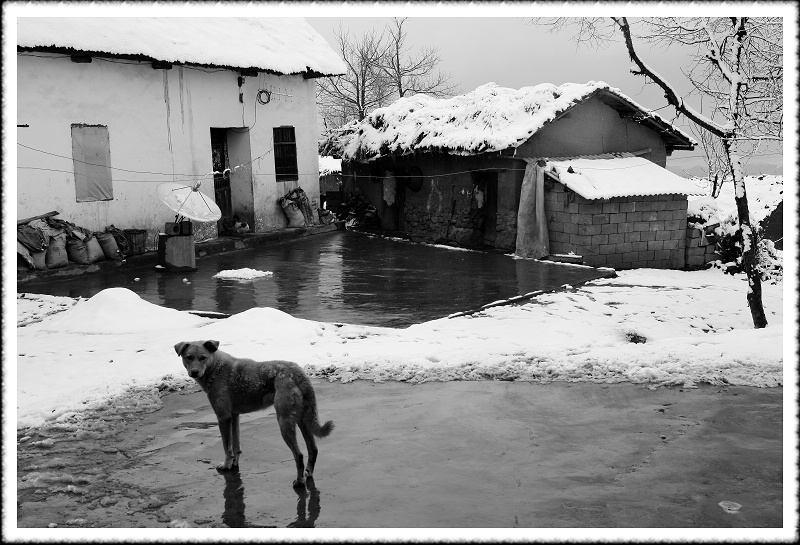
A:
72 123 114 202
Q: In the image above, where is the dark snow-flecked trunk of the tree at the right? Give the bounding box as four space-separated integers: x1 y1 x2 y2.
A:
723 139 767 329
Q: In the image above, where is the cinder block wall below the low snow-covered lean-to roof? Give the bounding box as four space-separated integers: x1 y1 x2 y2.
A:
544 181 688 269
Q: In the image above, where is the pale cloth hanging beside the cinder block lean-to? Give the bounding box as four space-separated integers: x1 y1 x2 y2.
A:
514 159 550 259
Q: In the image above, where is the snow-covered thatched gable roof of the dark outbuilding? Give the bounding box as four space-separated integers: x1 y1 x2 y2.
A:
320 81 695 161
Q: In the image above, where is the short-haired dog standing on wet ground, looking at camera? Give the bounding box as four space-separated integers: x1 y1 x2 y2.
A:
175 341 333 488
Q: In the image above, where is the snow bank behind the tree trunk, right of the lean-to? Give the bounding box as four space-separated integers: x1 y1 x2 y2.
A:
687 174 783 226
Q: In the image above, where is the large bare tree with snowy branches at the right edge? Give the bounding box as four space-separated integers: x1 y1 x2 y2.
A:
536 17 783 328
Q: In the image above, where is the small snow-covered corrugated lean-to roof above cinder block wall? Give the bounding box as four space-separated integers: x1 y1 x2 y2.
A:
545 153 703 199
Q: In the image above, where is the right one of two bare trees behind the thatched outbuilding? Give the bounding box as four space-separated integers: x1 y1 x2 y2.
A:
380 17 457 98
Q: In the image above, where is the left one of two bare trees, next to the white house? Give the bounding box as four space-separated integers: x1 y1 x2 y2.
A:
317 26 392 128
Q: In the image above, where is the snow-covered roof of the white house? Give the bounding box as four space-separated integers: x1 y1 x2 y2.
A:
17 17 346 75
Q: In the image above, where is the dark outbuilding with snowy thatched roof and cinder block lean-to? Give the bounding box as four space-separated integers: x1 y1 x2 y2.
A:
320 82 700 268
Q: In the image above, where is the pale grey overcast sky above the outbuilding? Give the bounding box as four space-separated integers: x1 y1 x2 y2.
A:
306 12 783 174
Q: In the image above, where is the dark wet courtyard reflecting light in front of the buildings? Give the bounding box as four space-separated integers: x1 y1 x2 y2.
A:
18 231 600 327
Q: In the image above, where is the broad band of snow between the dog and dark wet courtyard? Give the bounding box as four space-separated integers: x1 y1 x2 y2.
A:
16 269 783 427
